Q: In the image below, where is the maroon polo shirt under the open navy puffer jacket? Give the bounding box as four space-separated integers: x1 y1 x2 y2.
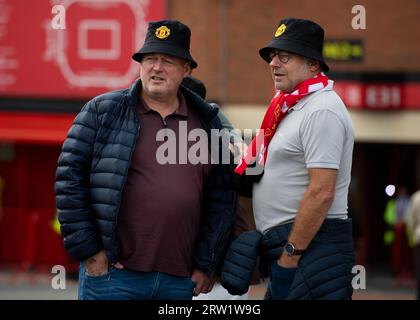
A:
117 92 211 276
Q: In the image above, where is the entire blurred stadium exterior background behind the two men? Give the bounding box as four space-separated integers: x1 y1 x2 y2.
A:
0 0 420 299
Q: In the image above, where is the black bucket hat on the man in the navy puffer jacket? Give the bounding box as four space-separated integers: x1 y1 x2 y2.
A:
132 20 197 68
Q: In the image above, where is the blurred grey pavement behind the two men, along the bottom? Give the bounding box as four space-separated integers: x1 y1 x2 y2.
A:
0 268 415 300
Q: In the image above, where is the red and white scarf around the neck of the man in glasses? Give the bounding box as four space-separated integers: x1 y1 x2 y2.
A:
235 72 328 175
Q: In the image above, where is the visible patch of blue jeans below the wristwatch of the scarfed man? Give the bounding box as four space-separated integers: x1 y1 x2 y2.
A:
268 260 297 300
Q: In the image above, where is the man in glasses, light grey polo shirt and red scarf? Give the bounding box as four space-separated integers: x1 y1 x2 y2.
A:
236 18 354 299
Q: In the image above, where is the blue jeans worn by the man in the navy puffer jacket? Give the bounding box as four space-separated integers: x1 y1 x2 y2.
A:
79 263 195 300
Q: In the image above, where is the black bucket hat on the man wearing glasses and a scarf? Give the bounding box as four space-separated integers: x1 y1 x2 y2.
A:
259 18 330 72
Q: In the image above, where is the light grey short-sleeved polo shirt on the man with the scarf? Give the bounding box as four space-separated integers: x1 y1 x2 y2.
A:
252 80 354 232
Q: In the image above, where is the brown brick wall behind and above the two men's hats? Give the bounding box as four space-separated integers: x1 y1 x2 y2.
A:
167 0 420 104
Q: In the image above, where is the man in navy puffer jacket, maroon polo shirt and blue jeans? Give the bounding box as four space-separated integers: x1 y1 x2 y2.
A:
55 20 236 299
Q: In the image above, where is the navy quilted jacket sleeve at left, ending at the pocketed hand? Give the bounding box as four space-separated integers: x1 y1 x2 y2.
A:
55 100 102 261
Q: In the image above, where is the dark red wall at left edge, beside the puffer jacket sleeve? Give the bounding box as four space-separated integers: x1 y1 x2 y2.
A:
0 144 77 270
